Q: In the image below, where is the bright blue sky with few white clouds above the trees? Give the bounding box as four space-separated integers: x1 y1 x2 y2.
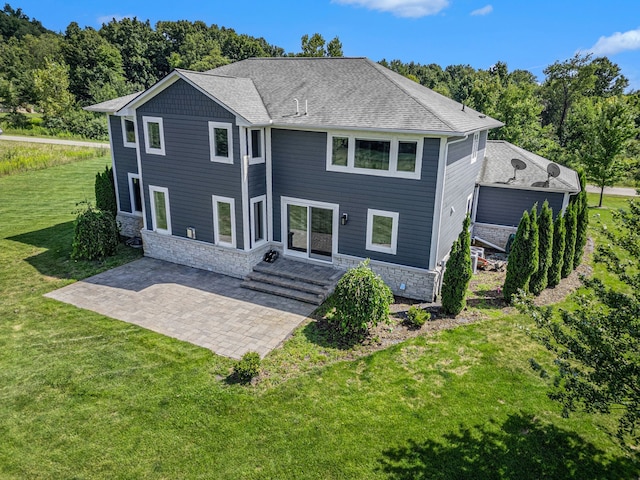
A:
11 0 640 89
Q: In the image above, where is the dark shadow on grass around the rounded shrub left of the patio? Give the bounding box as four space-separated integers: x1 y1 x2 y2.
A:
7 221 142 280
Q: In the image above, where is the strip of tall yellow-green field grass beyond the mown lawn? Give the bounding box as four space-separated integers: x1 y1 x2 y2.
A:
0 142 109 177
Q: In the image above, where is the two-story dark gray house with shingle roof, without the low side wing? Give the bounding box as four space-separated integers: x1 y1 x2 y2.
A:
88 58 501 300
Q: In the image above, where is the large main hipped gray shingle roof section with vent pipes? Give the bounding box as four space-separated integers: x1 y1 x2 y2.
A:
208 57 502 134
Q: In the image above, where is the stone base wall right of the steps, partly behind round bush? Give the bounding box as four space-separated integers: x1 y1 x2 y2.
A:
333 254 440 302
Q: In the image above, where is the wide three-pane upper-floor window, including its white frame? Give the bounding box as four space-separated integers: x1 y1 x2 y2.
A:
327 133 423 179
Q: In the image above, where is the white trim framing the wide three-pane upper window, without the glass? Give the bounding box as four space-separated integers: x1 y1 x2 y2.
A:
326 132 424 180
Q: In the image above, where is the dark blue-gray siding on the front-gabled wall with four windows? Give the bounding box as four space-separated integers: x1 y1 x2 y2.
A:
136 80 243 248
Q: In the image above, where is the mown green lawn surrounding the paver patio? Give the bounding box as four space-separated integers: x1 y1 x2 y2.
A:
0 159 639 480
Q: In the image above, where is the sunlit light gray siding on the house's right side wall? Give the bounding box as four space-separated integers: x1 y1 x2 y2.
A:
437 131 487 262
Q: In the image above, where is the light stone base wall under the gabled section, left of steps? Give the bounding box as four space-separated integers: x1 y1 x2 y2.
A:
141 230 269 278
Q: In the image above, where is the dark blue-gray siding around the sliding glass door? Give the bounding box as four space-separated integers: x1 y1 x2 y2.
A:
271 129 440 268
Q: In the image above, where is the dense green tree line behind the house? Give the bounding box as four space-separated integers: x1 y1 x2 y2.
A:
0 4 640 191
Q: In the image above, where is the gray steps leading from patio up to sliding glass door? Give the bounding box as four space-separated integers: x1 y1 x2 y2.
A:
242 258 344 305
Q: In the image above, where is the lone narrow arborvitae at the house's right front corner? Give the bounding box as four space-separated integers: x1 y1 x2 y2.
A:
442 215 473 315
